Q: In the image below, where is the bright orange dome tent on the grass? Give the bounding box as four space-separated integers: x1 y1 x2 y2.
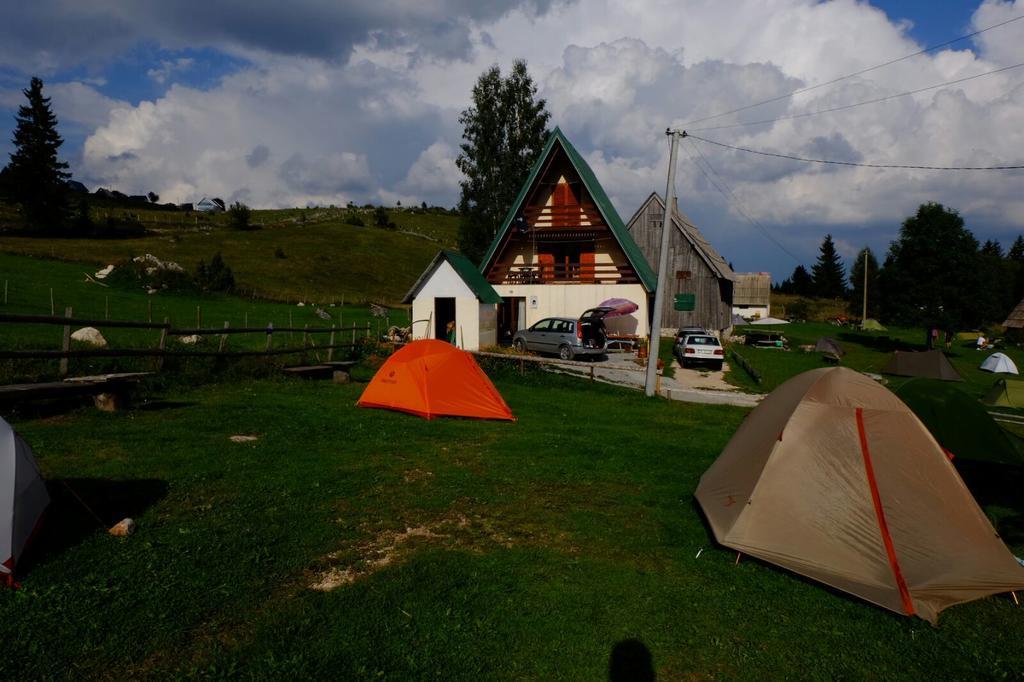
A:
356 339 515 420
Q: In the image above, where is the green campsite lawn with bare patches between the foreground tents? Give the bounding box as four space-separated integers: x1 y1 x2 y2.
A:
0 369 1024 680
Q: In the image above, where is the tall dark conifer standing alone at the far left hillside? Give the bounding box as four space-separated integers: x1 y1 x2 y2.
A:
7 78 71 232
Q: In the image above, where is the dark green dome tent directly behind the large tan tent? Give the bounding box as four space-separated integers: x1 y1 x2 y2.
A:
894 379 1024 464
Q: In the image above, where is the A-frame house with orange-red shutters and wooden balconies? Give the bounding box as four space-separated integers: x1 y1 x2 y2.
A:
480 128 655 340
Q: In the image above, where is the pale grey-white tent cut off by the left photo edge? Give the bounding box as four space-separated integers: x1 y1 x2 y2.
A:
0 419 50 582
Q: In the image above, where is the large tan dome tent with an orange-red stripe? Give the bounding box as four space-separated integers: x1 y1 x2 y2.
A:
696 368 1024 623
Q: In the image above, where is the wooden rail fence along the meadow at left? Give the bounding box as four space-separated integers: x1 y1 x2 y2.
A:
0 308 371 377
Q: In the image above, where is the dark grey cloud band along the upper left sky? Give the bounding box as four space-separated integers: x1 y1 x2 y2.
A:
0 0 569 73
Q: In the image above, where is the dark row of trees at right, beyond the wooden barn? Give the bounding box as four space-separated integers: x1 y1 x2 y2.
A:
774 202 1024 331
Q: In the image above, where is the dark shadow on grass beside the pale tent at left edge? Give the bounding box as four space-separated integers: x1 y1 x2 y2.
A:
17 478 169 574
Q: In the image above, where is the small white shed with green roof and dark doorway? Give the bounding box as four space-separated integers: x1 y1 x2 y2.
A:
402 246 502 350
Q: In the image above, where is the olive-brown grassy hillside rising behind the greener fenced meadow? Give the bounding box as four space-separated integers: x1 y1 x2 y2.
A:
0 201 459 303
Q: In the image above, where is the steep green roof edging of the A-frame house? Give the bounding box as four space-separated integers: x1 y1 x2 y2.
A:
480 127 657 292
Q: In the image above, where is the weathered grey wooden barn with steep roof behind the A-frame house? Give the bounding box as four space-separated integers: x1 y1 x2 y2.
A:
628 193 735 331
